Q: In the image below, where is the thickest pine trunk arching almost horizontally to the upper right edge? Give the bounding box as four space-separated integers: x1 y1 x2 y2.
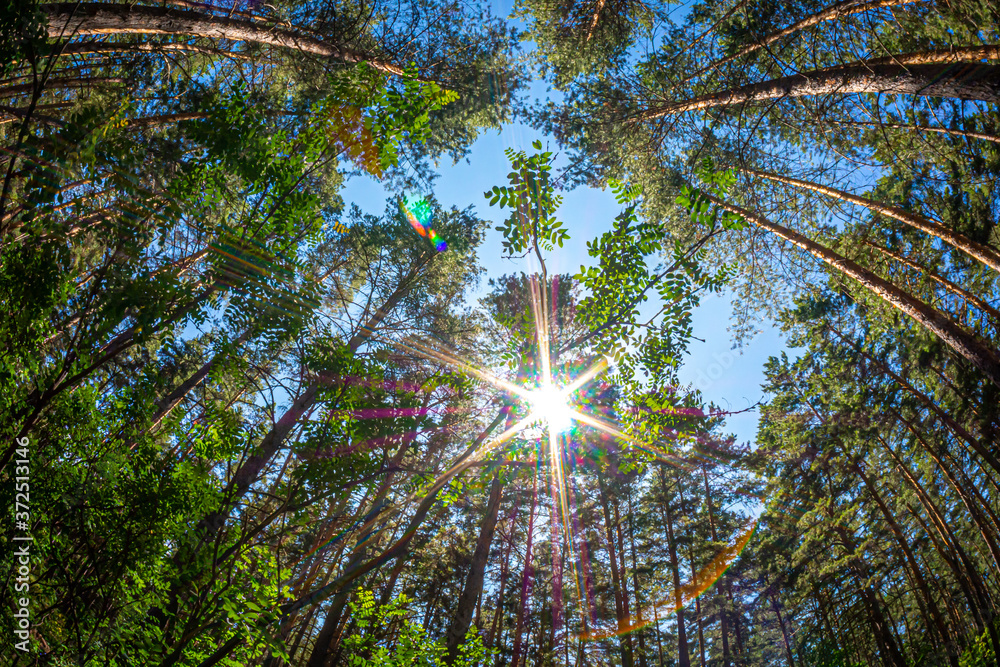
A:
636 59 1000 121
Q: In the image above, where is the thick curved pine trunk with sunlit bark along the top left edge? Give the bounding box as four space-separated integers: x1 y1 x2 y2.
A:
39 2 403 75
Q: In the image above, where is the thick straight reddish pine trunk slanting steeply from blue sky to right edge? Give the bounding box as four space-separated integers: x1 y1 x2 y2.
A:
703 193 1000 387
